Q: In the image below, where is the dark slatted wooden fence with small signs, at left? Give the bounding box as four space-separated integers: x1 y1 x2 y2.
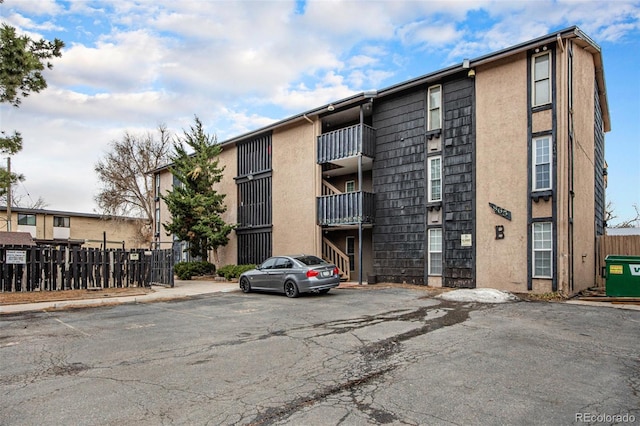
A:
0 246 173 292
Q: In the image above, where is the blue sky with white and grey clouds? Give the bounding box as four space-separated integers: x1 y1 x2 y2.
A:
0 0 640 223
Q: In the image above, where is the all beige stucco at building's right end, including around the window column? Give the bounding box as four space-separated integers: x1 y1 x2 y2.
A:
476 46 595 293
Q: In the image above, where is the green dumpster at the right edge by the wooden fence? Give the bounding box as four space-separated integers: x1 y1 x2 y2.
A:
604 255 640 297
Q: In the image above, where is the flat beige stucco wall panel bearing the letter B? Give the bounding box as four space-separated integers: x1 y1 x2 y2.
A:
475 53 529 292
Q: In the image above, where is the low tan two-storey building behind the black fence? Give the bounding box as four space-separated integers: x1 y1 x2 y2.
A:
0 207 149 249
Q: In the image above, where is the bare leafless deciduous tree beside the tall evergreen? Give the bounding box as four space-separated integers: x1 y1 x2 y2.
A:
94 124 171 242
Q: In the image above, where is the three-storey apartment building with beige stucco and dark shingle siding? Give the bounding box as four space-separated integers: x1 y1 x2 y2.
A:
154 27 610 294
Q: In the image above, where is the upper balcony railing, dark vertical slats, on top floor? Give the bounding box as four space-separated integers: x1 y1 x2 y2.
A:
318 124 375 164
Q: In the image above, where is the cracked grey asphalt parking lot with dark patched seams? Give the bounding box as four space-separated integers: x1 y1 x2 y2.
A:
0 286 640 425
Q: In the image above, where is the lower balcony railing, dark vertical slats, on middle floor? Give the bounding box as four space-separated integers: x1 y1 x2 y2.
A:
317 192 375 226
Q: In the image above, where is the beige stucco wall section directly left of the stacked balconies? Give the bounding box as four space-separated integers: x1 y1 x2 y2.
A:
272 120 321 255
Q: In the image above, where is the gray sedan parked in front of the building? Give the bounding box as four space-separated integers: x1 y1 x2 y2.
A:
240 254 340 297
